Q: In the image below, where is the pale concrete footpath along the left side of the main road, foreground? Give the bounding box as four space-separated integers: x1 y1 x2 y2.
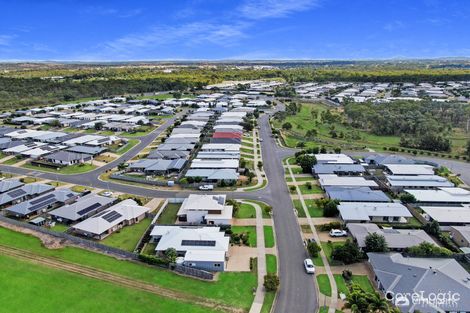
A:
241 201 267 313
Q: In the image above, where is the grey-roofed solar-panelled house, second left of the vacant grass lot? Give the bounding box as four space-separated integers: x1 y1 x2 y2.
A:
49 193 116 223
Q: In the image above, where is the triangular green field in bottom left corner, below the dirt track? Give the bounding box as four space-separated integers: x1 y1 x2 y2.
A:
0 255 216 313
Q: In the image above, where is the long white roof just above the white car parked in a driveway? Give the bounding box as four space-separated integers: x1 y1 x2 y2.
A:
338 202 412 221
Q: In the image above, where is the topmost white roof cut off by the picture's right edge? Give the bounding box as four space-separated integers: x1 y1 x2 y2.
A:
405 188 470 203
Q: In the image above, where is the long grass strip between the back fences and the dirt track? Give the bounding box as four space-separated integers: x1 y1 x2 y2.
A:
0 228 257 312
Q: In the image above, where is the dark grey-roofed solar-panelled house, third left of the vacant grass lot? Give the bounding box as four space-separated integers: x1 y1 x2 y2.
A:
5 189 78 218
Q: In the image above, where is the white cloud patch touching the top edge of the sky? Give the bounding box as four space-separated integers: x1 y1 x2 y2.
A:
239 0 319 20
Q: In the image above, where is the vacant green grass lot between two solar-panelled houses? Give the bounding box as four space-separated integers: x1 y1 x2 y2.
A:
101 218 152 252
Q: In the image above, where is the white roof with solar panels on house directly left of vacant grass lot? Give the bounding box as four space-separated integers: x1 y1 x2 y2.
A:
73 199 149 235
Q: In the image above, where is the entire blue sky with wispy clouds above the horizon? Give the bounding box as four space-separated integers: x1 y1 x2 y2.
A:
0 0 470 61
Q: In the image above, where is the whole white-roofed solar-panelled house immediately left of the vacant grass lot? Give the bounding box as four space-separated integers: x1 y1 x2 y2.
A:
72 199 150 240
